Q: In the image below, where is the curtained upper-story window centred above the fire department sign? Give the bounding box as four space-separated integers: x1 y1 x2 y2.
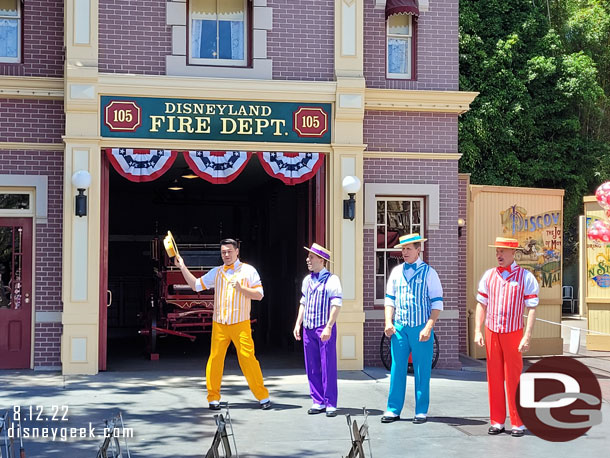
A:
189 0 251 67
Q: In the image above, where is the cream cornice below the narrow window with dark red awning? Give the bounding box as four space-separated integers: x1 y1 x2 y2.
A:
364 88 479 114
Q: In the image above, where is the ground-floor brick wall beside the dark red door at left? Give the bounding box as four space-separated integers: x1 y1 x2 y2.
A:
0 150 64 368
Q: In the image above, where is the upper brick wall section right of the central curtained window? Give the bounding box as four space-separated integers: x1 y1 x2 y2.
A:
267 0 335 81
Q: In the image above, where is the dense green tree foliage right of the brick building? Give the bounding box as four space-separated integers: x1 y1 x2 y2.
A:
459 0 610 257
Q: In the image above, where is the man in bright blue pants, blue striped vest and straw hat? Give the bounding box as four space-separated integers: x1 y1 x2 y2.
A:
381 233 443 424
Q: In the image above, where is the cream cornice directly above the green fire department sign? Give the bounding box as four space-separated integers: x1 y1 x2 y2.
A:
98 73 337 103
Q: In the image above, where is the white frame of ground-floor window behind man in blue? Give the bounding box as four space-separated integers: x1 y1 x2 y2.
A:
373 195 426 305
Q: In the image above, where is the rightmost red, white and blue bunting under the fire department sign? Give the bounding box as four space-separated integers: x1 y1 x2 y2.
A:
258 152 324 185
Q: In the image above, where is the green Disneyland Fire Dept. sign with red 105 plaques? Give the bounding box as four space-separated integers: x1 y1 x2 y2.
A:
100 96 332 143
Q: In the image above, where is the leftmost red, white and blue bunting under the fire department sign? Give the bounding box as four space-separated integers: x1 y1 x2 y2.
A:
106 148 178 183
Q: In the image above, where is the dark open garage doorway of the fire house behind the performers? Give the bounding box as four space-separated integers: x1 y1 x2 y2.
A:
102 154 324 369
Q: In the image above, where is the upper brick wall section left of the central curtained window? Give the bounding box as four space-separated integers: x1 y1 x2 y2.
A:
99 0 172 75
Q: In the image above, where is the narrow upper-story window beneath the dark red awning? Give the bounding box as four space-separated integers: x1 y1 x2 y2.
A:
386 14 415 79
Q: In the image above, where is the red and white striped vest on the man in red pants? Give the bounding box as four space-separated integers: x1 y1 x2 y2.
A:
486 266 526 333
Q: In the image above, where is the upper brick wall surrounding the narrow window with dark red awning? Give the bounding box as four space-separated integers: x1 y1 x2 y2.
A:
364 0 459 91
